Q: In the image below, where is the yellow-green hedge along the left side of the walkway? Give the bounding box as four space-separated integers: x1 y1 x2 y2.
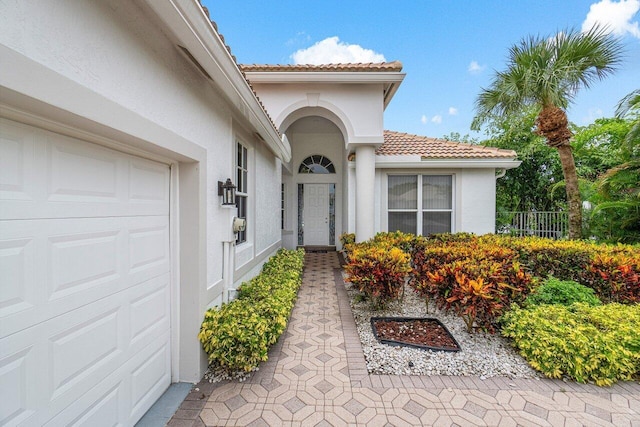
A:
198 249 304 372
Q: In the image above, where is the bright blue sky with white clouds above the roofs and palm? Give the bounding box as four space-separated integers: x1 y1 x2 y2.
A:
203 0 640 138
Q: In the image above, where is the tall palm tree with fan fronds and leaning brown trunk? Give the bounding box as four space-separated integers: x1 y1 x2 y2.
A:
472 27 622 239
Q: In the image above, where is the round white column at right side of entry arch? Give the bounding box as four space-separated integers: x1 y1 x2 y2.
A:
356 145 376 242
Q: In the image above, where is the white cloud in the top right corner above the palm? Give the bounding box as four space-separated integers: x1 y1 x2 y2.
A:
582 0 640 38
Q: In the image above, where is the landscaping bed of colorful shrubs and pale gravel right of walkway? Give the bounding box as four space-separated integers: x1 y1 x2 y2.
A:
345 232 640 385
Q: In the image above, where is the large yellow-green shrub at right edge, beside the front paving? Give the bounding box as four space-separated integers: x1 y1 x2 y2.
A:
502 303 640 385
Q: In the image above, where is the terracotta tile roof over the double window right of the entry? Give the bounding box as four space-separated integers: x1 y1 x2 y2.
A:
376 130 516 159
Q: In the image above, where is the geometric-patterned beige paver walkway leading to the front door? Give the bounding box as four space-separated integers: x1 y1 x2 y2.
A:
168 253 640 427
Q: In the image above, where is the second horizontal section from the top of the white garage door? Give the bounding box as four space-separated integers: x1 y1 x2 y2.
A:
0 217 170 336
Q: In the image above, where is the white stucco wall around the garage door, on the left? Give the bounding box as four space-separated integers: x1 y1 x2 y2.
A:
0 0 280 381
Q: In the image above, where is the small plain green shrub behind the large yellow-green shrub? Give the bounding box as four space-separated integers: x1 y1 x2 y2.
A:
525 277 602 306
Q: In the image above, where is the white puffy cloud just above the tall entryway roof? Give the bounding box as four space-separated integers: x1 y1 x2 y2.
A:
291 36 386 65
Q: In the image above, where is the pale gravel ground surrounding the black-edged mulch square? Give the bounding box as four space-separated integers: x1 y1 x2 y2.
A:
345 283 542 378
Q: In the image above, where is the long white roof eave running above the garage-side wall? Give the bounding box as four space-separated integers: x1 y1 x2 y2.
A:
146 0 291 162
